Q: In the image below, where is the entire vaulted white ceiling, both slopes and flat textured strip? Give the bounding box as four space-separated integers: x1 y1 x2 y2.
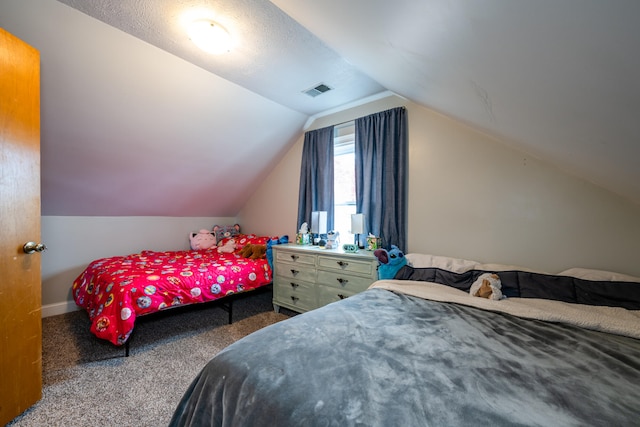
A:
0 0 640 216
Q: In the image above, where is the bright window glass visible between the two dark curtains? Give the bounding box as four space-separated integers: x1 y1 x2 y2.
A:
333 122 356 243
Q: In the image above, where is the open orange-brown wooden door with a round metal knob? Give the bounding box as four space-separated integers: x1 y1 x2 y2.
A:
0 28 42 425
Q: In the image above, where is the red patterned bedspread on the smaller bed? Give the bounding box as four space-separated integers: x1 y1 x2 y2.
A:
73 235 272 345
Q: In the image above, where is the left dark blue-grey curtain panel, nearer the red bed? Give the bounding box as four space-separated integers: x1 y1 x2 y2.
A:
296 126 333 230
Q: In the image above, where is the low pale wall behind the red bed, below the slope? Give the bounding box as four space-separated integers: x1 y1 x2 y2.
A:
40 216 236 317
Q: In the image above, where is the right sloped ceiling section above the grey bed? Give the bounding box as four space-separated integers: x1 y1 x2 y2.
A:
273 0 640 205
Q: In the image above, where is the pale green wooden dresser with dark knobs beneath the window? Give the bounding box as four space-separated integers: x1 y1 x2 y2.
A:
273 244 378 313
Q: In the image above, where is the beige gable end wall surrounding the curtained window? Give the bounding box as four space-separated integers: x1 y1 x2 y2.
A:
239 97 640 276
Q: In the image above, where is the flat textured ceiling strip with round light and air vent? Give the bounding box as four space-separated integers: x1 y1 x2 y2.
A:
53 0 384 115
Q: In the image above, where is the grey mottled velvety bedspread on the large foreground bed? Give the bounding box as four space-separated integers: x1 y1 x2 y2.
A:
171 289 640 427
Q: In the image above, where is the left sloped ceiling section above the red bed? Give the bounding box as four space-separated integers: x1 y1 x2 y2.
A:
0 0 308 217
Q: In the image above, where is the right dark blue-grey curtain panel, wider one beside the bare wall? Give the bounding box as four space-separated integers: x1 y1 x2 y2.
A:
355 107 408 252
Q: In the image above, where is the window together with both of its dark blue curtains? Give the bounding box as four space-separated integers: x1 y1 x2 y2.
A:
297 107 408 250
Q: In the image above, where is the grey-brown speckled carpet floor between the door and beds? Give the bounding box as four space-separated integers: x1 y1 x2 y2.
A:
9 287 293 427
